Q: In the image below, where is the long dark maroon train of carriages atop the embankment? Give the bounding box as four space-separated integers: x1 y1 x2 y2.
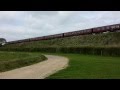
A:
7 24 120 44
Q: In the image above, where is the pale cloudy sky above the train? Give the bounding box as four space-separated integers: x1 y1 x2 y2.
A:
0 11 120 41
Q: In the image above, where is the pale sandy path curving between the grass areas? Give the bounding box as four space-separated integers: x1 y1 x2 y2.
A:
0 55 68 79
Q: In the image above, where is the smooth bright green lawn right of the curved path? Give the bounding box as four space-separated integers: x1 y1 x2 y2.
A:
47 54 120 79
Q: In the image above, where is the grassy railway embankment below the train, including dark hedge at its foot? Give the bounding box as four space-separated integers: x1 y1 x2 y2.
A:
0 32 120 56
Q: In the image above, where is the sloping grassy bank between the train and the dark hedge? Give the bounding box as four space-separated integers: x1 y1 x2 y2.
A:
2 32 120 48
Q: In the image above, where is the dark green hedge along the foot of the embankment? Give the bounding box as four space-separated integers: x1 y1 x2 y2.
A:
0 47 120 56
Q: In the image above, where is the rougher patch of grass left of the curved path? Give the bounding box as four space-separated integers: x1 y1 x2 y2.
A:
0 52 47 72
